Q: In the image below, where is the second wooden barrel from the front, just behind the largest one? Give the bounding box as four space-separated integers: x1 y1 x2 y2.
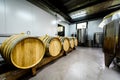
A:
39 35 62 56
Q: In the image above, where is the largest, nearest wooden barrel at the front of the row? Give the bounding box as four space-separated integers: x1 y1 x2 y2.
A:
0 34 45 69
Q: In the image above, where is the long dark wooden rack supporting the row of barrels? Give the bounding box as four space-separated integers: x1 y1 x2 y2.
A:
0 48 75 80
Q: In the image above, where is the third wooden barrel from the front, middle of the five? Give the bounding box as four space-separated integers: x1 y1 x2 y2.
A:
59 37 70 52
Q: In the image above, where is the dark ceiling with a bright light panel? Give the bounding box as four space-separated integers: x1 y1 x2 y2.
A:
27 0 120 23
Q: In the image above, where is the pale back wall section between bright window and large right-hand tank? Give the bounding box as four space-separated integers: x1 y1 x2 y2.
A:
88 19 103 40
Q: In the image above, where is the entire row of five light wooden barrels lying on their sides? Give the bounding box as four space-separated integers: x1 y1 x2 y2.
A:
0 34 78 69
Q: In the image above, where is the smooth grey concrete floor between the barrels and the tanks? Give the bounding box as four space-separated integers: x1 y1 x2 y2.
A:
29 47 120 80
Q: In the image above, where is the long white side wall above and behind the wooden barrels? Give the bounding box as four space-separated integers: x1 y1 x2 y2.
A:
0 0 69 43
